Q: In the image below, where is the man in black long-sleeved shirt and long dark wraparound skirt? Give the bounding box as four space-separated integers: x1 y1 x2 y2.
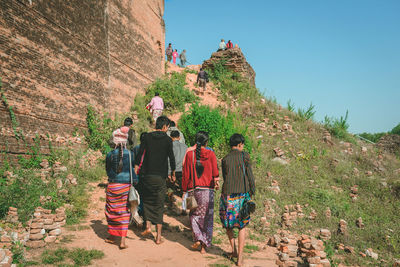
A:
135 116 175 245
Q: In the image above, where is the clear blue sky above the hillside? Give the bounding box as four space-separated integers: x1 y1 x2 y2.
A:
164 0 400 133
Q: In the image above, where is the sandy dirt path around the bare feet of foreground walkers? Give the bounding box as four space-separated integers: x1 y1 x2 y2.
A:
64 181 277 267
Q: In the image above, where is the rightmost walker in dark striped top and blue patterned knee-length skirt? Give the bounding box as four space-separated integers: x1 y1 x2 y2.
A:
219 134 255 266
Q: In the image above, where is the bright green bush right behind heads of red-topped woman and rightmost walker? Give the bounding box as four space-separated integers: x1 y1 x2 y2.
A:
179 104 252 156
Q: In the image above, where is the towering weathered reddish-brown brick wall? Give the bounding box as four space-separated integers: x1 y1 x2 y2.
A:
0 0 165 157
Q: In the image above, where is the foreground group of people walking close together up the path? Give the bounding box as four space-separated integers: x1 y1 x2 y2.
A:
105 116 255 265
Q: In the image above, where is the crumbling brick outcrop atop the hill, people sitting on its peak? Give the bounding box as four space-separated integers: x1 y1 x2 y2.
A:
202 48 256 86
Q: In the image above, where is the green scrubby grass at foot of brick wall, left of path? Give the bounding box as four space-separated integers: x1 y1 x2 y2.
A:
0 147 105 224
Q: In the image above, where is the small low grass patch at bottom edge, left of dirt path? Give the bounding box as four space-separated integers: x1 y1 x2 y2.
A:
41 248 104 266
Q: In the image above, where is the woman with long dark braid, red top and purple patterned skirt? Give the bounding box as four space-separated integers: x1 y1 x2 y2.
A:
182 131 219 254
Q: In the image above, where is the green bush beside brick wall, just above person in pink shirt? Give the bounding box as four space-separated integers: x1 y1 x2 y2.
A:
143 72 199 113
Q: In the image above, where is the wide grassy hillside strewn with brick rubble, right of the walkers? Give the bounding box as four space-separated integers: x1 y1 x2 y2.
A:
202 62 400 266
